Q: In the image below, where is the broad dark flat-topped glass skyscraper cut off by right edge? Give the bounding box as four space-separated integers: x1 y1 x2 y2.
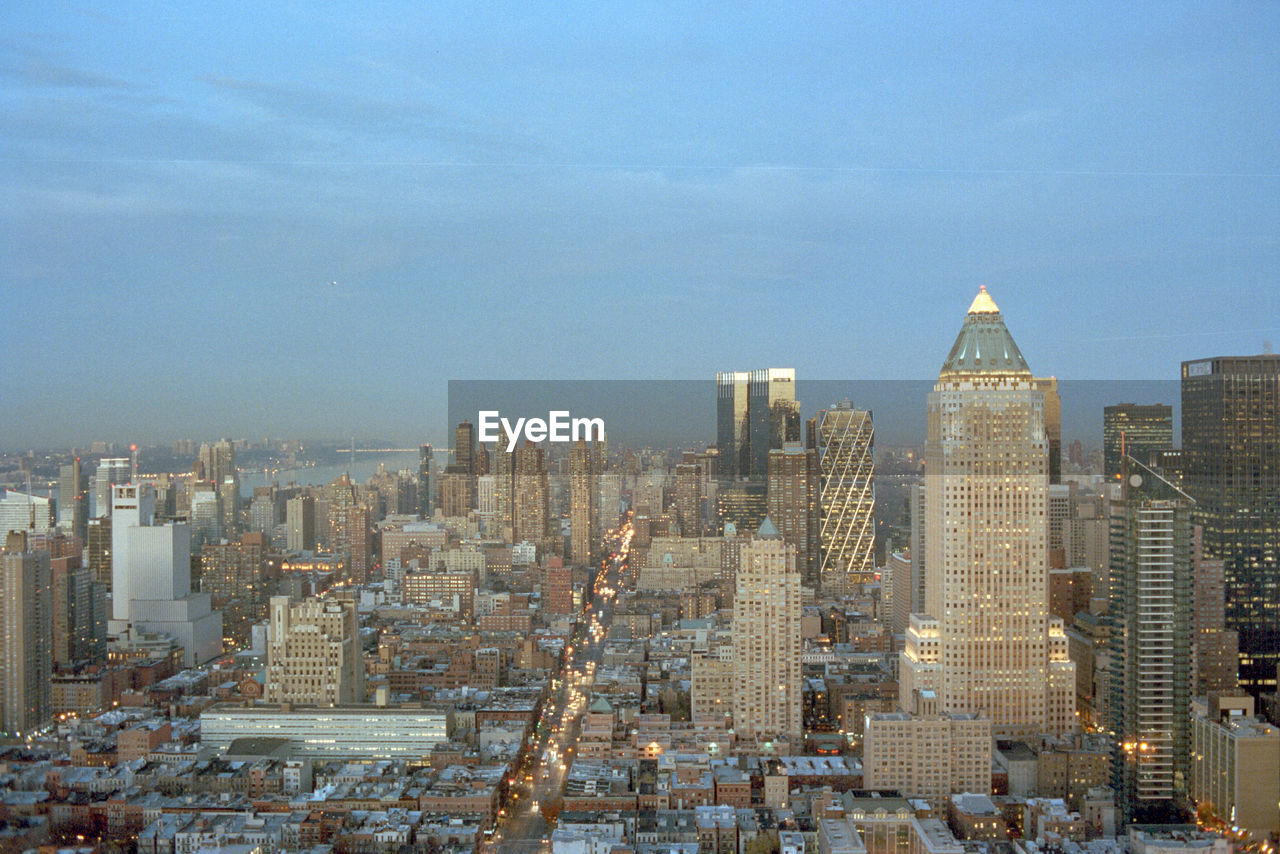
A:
1183 355 1280 693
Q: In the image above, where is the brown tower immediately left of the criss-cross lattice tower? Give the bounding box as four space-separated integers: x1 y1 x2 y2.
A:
768 442 814 589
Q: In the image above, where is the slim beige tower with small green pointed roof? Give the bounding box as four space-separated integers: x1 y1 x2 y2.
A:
733 519 804 739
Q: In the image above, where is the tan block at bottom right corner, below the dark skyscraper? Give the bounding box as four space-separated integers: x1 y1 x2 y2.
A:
1190 695 1280 839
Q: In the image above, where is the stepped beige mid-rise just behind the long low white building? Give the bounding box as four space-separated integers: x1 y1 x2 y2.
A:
264 597 365 705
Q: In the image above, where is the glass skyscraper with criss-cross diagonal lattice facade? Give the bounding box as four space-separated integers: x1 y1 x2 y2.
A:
809 401 876 590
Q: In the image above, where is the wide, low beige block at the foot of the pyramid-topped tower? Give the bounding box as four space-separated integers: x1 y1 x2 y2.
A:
863 693 991 799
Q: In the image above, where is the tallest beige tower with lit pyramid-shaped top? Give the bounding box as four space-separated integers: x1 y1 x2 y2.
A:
900 288 1075 735
